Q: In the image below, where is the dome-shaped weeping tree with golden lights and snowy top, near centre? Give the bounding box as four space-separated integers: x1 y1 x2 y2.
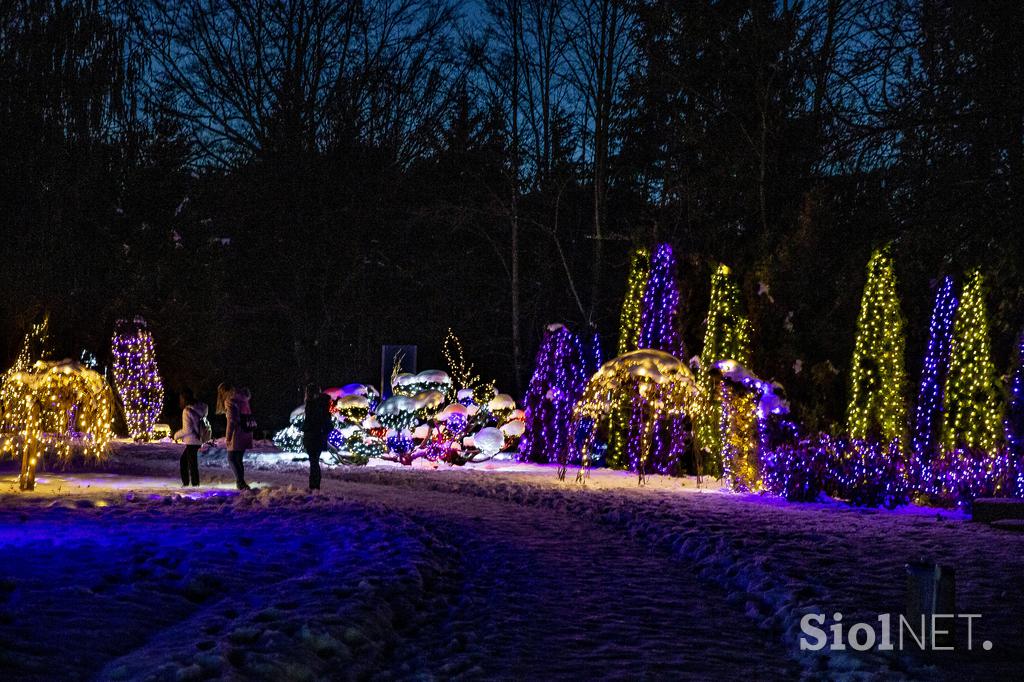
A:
558 349 706 483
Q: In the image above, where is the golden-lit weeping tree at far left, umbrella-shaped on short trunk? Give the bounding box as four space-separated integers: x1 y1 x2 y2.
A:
0 360 113 491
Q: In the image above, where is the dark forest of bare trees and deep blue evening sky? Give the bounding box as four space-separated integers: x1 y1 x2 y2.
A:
0 0 1024 428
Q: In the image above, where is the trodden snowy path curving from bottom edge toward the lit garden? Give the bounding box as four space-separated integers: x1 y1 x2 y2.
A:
327 477 796 679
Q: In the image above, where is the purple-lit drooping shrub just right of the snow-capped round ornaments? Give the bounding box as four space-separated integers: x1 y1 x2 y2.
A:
519 325 590 463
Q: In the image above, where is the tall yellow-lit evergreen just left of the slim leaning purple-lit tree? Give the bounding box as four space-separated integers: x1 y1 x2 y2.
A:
847 248 907 441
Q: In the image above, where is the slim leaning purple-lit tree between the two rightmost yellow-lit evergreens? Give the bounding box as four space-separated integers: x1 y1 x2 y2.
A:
913 276 957 462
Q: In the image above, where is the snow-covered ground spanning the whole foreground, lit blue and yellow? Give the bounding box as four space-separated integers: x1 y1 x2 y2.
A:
0 444 1024 680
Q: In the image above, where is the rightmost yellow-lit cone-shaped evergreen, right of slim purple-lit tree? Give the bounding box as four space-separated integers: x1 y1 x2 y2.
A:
942 270 1002 452
